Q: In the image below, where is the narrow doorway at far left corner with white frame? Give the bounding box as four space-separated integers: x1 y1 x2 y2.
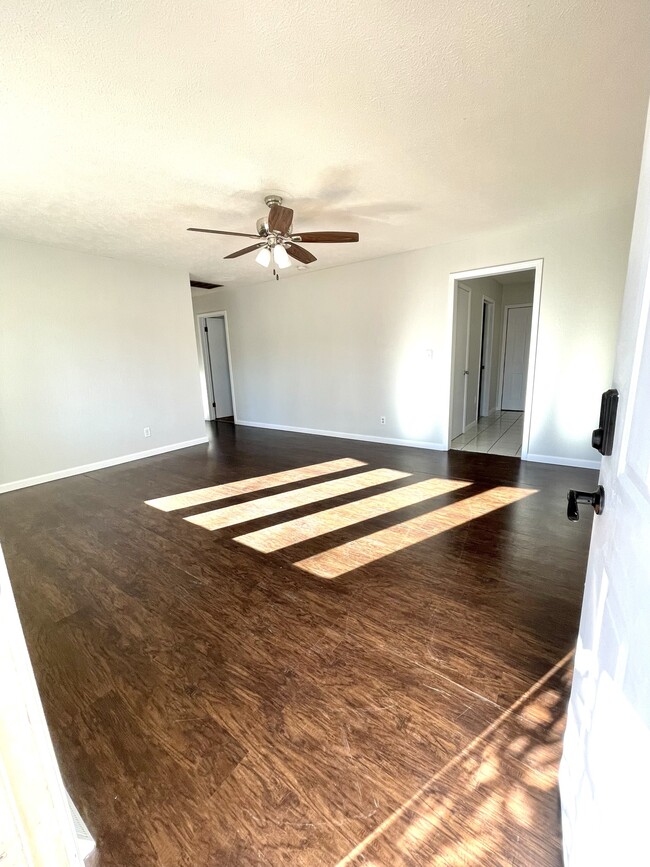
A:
198 312 236 423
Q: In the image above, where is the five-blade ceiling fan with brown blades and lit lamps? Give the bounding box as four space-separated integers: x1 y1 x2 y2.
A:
187 196 359 279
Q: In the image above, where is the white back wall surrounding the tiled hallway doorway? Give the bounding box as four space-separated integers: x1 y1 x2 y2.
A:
195 203 633 462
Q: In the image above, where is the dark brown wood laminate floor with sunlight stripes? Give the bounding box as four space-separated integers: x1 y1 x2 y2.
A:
0 424 596 867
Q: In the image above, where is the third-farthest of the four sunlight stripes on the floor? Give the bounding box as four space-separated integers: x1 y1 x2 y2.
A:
235 479 471 554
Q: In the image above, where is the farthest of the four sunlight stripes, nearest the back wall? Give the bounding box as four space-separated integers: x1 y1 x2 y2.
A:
145 458 367 512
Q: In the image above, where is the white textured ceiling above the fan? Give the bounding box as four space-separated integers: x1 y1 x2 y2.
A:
0 0 650 283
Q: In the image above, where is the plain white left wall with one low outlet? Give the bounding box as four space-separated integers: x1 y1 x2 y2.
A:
0 239 205 491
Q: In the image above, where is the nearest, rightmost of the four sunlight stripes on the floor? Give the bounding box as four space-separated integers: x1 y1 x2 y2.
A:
294 487 537 578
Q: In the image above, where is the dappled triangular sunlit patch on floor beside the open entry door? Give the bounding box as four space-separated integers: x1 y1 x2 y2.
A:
338 653 573 867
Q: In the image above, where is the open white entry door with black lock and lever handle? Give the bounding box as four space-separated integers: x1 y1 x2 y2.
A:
560 110 650 867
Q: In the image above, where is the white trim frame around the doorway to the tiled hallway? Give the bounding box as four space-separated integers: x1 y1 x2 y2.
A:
443 259 544 461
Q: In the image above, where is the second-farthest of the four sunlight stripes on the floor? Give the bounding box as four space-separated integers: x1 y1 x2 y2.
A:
185 469 411 530
